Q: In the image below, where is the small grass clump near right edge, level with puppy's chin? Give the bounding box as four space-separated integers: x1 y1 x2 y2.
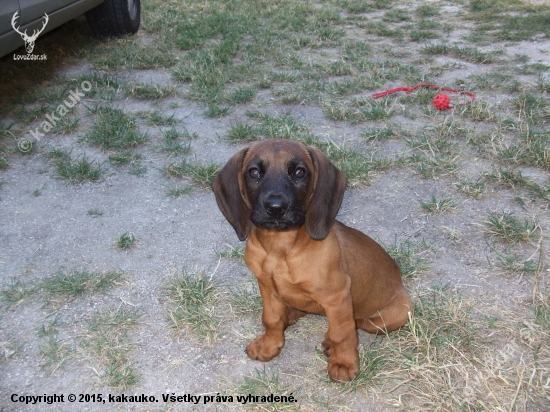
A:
484 212 540 244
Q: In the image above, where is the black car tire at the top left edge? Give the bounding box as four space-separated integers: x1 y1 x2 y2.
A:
86 0 141 36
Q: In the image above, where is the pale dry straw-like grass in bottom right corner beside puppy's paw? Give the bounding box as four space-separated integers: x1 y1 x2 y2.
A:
353 287 550 411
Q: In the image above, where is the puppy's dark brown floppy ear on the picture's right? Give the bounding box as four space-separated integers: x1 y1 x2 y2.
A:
306 146 347 240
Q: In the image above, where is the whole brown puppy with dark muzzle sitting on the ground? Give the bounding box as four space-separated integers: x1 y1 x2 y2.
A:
212 140 413 381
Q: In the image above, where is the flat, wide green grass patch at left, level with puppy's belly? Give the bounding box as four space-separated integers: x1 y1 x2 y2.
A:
37 269 124 304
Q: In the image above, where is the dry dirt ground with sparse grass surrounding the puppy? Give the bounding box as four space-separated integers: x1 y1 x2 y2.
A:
0 0 550 411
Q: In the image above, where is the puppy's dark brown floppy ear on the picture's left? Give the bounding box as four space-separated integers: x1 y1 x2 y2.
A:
212 148 251 240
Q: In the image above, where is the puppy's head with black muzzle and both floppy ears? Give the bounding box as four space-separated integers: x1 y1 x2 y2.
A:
212 140 346 240
